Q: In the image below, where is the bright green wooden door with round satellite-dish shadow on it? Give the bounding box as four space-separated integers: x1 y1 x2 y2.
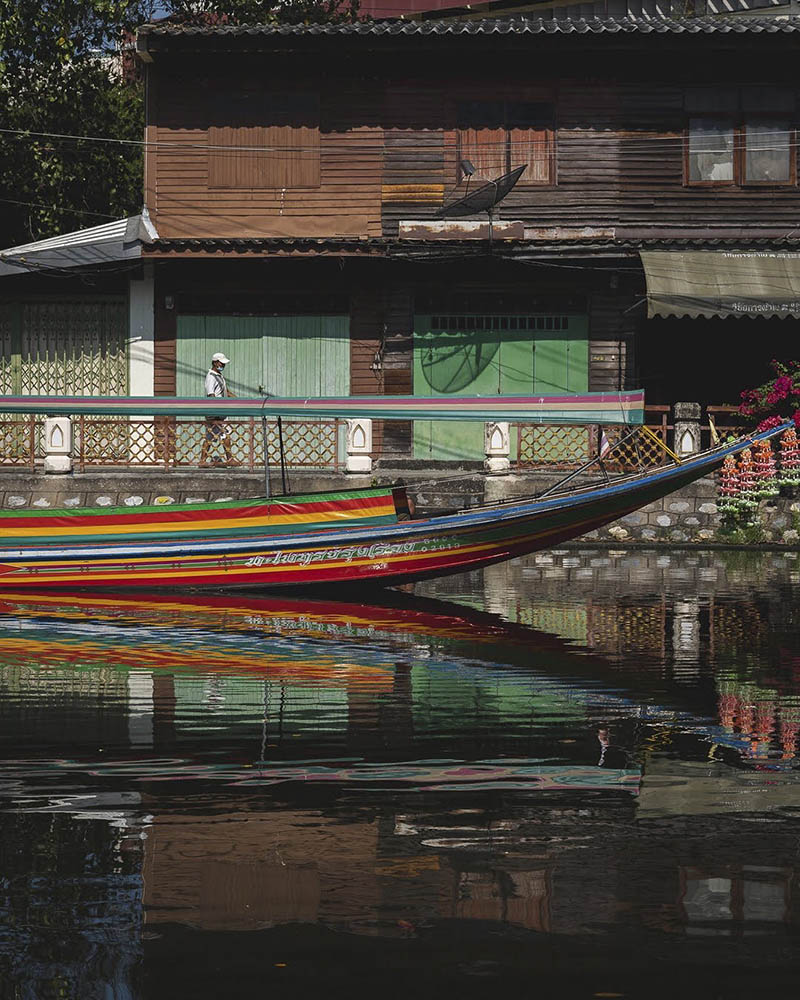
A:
414 314 589 461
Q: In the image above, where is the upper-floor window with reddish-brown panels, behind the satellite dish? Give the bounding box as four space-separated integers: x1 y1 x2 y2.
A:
457 101 555 185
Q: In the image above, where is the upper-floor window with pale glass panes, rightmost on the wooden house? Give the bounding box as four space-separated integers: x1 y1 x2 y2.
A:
685 87 797 186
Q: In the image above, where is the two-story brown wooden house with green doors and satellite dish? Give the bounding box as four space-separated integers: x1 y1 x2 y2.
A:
1 16 800 458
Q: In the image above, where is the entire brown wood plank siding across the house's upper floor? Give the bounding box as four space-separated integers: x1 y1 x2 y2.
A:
146 47 800 238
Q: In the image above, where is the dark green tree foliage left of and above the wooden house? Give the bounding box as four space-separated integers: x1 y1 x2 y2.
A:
0 0 358 248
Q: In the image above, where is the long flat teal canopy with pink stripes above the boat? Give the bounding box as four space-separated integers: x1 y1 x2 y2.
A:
0 389 644 424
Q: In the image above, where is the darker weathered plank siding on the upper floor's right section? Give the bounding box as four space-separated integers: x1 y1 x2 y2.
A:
383 74 800 238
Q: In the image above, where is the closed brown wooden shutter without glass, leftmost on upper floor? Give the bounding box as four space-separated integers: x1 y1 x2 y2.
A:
208 91 320 189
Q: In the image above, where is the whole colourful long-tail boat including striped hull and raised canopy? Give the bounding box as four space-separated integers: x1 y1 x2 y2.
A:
0 392 785 590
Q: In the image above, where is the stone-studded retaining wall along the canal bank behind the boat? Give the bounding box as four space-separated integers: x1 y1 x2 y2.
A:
0 469 800 546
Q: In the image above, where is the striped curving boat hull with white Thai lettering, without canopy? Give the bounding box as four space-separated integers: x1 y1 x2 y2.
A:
0 428 783 590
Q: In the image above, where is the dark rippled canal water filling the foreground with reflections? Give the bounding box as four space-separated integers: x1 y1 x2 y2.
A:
0 549 800 1000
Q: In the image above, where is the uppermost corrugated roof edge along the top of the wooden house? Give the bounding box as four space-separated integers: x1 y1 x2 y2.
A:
139 16 800 38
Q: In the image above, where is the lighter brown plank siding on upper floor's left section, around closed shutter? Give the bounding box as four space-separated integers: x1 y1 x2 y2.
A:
152 63 383 238
